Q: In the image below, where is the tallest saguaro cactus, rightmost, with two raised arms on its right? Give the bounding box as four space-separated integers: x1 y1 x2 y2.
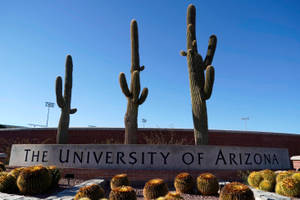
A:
181 4 217 145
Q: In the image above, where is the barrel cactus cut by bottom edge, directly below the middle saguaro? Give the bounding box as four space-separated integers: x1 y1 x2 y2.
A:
109 186 136 200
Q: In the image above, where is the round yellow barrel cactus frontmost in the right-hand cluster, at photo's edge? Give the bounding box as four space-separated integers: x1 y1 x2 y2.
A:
275 177 300 197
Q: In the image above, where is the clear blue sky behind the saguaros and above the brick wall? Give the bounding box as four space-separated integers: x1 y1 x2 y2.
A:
0 0 300 133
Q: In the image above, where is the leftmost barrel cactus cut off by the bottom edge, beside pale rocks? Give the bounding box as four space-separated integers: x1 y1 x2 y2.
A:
74 184 105 200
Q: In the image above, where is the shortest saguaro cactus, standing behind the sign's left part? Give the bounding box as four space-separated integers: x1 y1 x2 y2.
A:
56 55 77 144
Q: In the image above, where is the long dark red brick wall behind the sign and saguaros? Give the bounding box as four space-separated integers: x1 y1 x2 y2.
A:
0 128 300 156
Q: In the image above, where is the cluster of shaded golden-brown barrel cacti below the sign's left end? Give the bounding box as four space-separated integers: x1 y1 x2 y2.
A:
0 166 60 195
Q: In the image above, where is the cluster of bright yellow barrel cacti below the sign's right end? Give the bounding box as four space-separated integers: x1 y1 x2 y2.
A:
248 169 300 197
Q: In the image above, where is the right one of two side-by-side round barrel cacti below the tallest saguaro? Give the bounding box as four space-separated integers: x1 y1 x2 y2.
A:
197 173 219 195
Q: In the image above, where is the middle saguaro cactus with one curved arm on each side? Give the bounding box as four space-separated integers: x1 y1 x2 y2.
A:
119 20 148 144
